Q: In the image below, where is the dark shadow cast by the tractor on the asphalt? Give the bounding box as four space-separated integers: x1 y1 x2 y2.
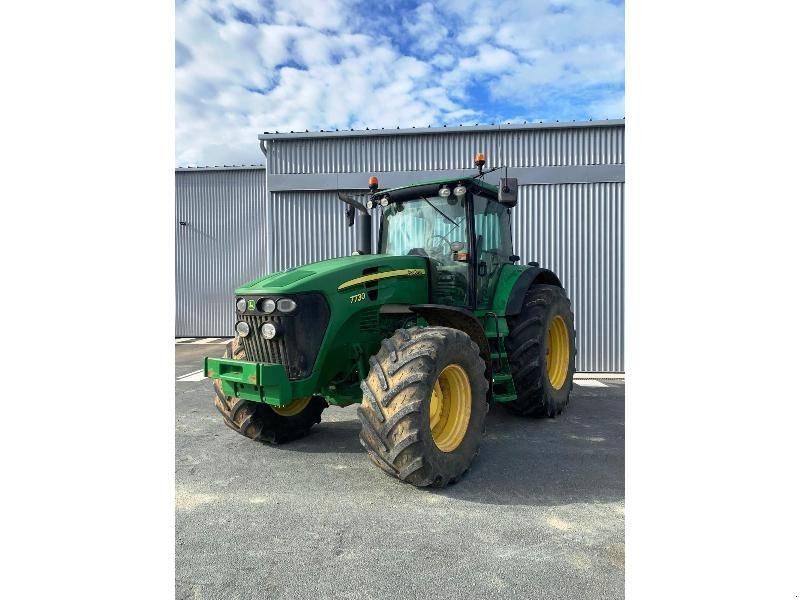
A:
281 385 625 506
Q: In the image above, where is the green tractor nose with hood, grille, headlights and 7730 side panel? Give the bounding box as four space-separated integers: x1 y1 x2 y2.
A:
228 254 430 406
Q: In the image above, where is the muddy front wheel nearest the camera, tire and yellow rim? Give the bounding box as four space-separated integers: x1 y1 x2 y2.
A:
358 327 489 487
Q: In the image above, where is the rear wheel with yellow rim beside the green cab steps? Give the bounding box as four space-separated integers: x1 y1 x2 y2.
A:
503 285 575 417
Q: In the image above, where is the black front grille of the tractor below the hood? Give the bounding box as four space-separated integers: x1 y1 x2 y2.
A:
239 294 330 379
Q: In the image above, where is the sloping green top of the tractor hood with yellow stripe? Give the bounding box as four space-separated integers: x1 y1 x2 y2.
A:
236 254 428 302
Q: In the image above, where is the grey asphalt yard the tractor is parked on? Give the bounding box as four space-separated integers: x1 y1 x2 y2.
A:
175 344 625 600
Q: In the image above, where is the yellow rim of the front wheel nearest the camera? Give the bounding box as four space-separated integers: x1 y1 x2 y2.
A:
430 364 472 452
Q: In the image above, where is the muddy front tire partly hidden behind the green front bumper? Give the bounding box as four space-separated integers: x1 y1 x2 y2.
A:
213 336 327 444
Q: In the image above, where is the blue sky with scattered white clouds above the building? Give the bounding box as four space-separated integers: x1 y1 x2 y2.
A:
175 0 625 166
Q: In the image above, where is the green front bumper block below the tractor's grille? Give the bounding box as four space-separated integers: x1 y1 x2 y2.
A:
203 358 294 406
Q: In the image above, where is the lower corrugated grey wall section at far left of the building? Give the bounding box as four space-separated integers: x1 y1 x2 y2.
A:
176 168 267 337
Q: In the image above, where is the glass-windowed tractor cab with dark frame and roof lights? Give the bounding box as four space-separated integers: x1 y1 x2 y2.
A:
367 172 518 310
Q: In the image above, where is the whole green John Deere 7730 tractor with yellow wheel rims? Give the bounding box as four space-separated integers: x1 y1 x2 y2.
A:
205 154 575 487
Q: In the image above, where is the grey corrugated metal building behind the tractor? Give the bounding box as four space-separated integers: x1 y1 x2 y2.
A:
175 121 625 372
